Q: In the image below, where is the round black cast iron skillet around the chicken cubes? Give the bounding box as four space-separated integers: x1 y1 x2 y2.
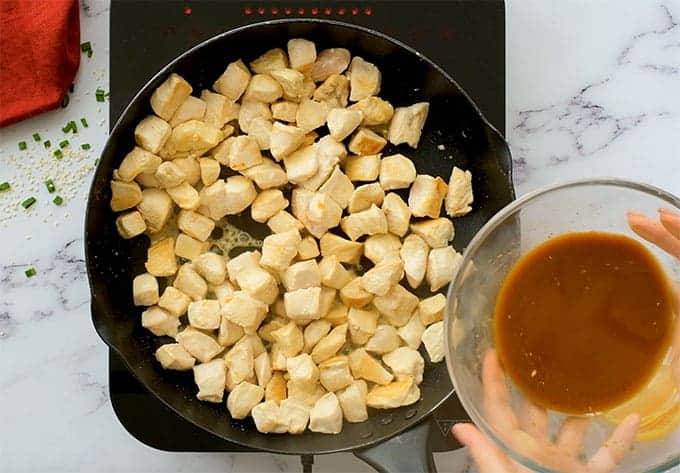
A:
85 19 514 471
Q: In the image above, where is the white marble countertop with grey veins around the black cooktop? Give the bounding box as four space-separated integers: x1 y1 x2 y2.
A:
0 0 680 472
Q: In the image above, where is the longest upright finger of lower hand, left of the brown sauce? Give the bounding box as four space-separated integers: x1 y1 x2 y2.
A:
482 350 517 433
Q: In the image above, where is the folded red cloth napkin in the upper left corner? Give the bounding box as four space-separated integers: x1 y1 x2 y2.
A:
0 0 80 127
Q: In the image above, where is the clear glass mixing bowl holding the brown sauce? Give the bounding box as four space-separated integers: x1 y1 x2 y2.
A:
444 179 680 473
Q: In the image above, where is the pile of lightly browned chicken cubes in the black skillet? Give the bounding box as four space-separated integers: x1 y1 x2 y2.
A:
111 39 473 434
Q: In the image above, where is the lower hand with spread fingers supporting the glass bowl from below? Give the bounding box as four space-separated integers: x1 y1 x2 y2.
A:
452 350 640 473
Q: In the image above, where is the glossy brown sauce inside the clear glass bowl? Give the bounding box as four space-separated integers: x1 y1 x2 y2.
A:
494 232 674 414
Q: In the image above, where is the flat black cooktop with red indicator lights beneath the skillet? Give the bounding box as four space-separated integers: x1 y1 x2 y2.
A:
109 0 505 452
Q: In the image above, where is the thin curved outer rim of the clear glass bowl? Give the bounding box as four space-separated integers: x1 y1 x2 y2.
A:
444 177 680 473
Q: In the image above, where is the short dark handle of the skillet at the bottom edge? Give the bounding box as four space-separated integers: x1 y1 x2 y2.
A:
354 419 437 473
